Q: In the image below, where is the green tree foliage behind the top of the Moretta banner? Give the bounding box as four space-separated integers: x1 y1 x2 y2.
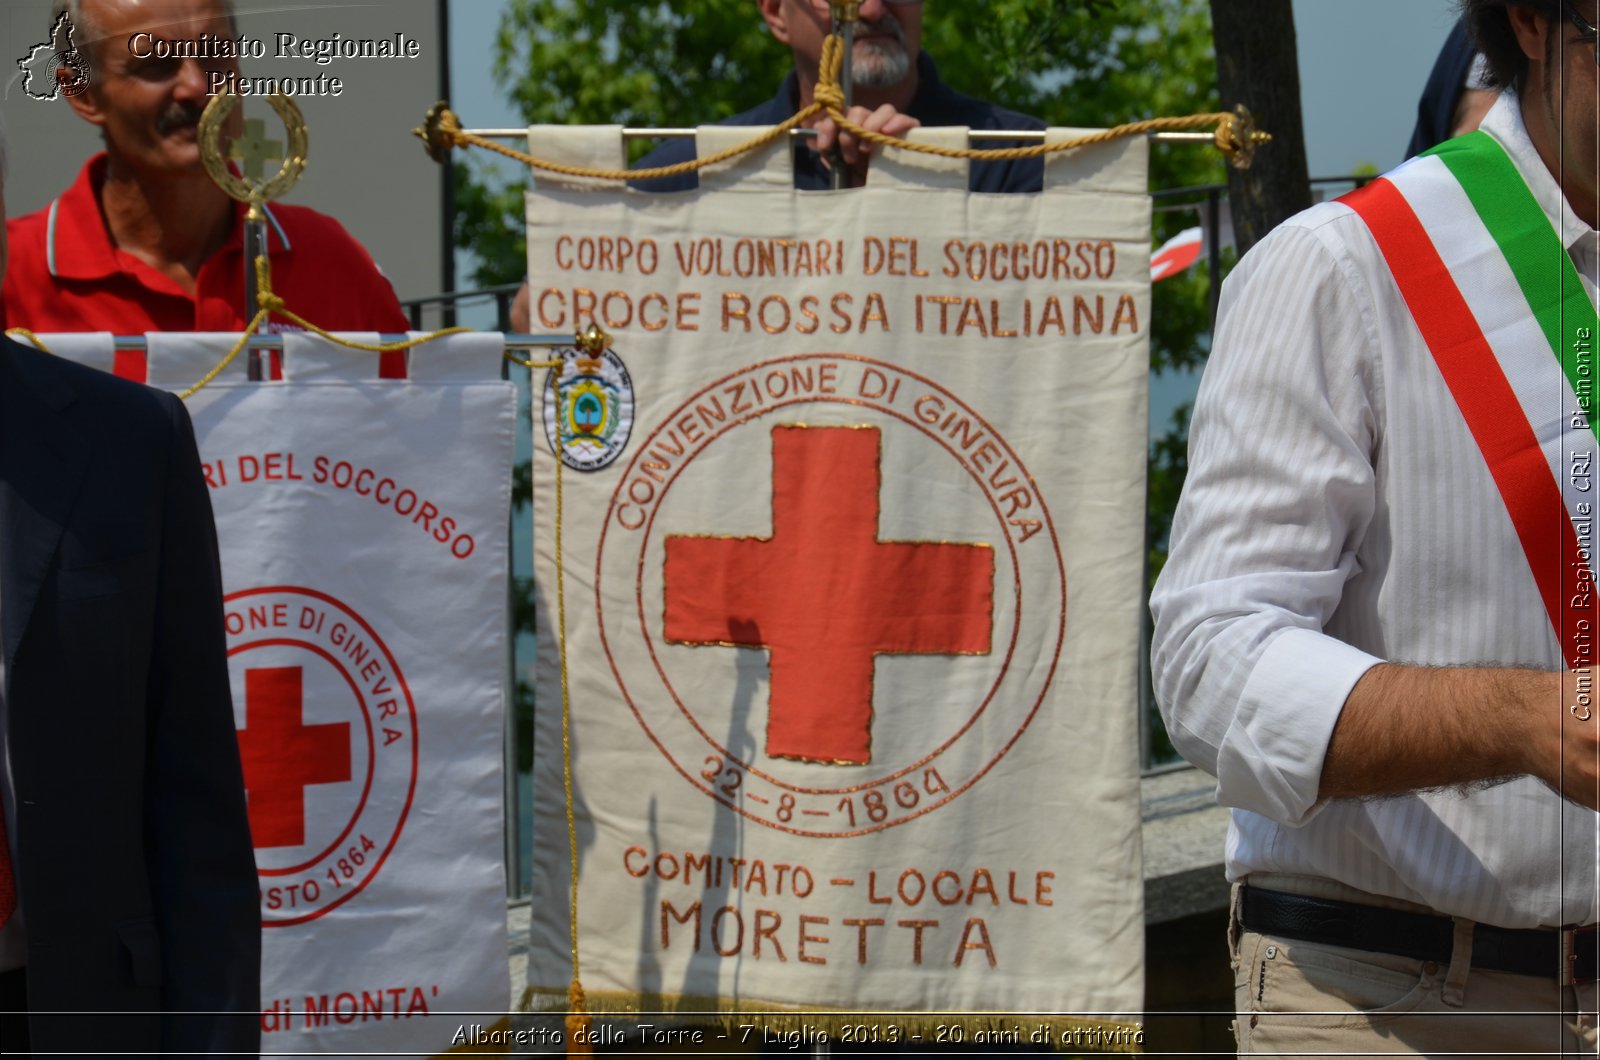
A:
456 0 1222 299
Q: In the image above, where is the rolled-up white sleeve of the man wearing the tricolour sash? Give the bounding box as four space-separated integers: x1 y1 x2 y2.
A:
1150 215 1382 826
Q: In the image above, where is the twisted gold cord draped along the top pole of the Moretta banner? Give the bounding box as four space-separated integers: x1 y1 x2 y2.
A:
416 35 1270 181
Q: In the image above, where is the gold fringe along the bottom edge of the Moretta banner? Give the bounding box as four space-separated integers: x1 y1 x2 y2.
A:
518 986 1144 1054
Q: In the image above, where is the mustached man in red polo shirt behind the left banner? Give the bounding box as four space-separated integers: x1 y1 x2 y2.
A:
0 0 408 378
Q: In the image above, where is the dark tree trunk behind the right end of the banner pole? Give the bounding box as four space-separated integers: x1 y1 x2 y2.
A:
1211 0 1310 255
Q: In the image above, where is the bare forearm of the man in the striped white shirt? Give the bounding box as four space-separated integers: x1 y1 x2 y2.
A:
1318 665 1600 809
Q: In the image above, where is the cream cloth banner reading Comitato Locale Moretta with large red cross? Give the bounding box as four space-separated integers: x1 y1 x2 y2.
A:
526 128 1150 1049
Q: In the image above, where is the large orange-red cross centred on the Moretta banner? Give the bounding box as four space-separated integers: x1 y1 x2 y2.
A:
666 426 995 764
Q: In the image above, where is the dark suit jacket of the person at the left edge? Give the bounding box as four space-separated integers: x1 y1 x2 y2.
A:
0 339 261 1052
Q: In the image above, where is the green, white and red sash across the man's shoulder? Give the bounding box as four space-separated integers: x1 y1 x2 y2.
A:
1339 133 1600 666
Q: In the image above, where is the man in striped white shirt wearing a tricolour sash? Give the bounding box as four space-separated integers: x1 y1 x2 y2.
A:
1150 0 1600 1055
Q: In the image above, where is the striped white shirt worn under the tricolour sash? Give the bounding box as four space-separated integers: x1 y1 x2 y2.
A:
1150 93 1600 927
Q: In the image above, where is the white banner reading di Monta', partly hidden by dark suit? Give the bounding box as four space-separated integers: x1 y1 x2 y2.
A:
43 335 515 1055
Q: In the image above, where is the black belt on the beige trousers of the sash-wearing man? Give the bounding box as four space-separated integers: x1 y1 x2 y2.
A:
1238 885 1600 986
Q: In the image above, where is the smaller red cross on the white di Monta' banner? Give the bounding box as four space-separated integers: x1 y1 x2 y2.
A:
238 666 350 849
